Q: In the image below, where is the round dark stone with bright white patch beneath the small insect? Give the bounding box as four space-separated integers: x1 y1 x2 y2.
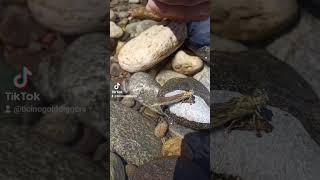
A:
158 78 210 130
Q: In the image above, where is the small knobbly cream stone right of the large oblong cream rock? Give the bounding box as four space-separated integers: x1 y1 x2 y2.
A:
171 50 203 75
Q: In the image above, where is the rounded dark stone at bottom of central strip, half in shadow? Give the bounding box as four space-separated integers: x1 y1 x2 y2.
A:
132 156 210 180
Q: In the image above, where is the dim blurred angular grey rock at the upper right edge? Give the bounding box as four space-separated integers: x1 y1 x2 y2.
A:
268 11 320 97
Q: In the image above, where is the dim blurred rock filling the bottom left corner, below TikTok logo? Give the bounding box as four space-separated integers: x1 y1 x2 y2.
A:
0 122 106 180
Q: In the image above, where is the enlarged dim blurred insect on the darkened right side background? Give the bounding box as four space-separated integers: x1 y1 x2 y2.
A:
211 95 273 137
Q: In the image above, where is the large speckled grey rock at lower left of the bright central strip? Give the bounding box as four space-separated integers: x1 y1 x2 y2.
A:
110 101 161 166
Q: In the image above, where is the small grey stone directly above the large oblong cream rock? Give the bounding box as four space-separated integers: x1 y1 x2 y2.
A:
126 20 158 38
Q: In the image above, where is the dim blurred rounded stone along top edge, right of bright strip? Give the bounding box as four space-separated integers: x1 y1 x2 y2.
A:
211 0 298 41
